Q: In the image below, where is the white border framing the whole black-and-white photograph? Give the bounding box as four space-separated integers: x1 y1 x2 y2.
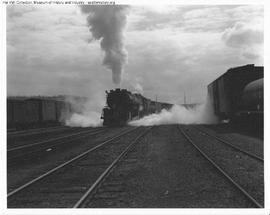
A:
0 0 270 215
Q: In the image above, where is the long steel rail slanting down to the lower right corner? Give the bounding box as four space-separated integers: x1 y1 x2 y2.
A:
177 125 263 208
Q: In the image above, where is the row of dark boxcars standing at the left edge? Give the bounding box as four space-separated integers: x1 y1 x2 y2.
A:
7 98 71 129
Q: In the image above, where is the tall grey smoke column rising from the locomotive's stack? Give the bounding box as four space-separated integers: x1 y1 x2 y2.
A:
81 5 128 85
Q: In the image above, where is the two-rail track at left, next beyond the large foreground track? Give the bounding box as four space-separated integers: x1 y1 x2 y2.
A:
7 128 106 164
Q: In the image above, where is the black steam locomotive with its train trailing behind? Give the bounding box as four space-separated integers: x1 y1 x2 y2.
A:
101 89 172 126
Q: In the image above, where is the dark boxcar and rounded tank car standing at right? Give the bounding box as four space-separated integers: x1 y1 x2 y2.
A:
208 64 264 129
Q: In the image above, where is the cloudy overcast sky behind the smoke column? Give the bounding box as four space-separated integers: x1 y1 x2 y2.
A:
7 5 263 106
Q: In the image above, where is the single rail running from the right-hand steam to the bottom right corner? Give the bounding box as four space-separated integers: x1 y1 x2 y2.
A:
178 125 264 208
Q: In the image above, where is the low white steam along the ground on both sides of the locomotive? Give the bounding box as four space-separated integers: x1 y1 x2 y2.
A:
66 95 218 127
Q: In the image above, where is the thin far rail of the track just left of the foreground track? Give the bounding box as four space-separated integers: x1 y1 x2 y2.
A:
7 128 104 152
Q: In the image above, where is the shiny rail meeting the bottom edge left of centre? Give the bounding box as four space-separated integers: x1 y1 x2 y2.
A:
73 127 152 208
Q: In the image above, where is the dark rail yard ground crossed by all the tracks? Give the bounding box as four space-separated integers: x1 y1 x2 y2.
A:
7 125 264 208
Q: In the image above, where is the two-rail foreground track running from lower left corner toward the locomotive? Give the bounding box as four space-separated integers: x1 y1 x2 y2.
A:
7 127 149 207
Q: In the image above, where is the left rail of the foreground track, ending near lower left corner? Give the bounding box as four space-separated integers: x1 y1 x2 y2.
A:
7 127 139 198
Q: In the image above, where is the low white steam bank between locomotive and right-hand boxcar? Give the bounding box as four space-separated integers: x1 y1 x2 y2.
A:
129 96 218 126
